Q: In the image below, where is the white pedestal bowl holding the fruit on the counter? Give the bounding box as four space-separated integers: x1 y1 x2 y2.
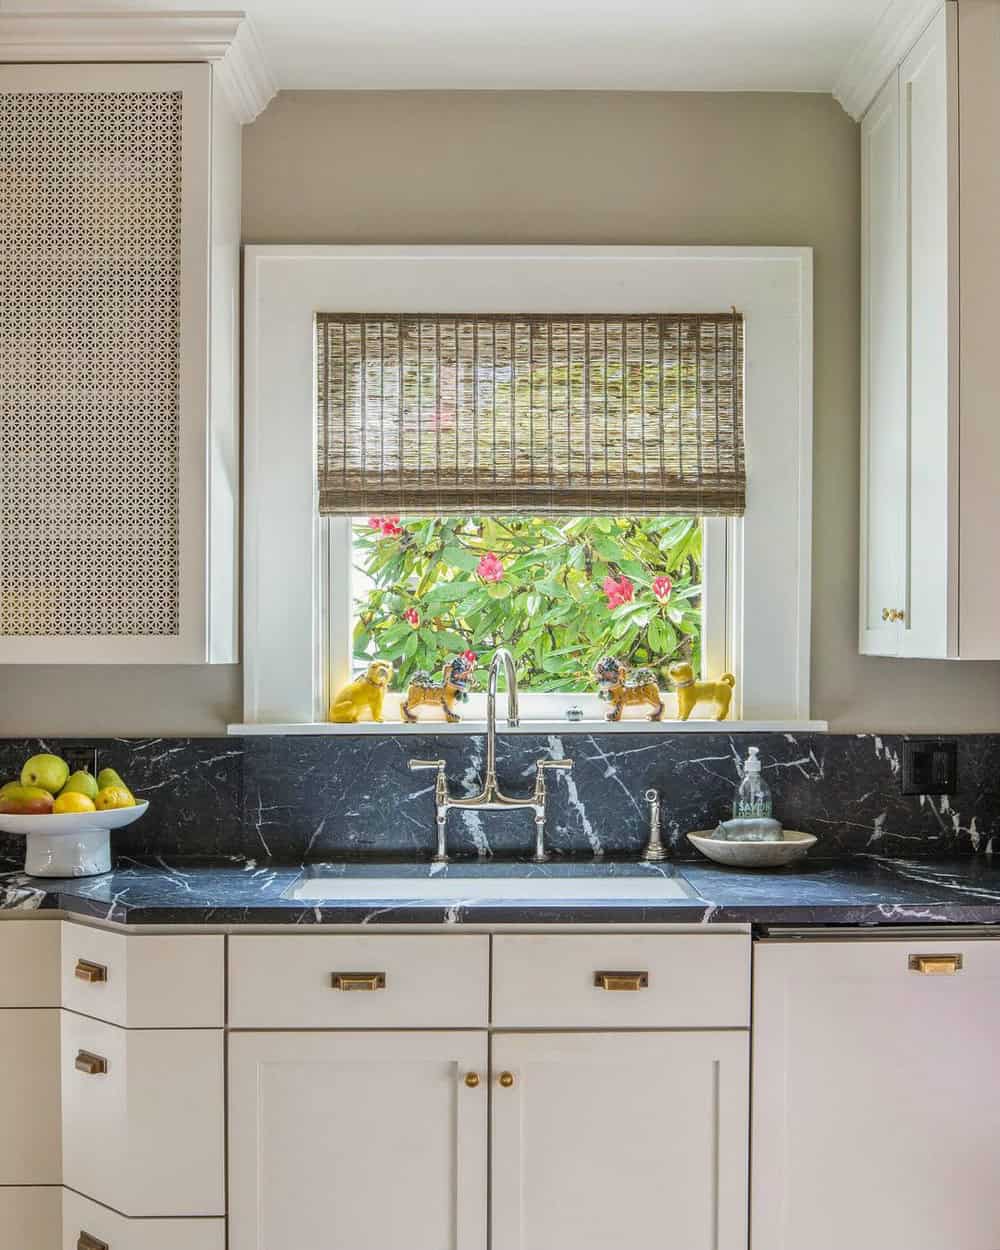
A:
0 803 149 876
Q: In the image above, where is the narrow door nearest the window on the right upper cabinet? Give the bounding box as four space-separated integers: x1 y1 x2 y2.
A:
860 74 908 655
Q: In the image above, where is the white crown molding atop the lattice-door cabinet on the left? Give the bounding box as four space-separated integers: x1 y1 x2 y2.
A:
0 11 278 124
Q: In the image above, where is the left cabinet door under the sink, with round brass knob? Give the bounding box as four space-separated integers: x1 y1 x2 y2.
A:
229 1031 489 1250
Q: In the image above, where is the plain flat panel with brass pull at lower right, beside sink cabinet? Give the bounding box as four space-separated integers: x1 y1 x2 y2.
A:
751 938 1000 1250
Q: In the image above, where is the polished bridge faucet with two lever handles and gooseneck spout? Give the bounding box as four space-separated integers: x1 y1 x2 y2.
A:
410 646 573 864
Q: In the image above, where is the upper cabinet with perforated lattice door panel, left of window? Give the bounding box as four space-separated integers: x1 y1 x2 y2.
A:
0 63 240 664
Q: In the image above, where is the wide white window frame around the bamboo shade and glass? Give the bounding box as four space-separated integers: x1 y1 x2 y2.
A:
238 245 825 733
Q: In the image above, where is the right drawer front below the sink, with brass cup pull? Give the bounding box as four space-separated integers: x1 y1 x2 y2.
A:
493 934 750 1029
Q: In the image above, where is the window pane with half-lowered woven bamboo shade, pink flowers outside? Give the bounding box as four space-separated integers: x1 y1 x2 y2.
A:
316 309 745 719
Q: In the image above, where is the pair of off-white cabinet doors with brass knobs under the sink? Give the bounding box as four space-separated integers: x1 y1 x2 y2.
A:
229 1030 749 1250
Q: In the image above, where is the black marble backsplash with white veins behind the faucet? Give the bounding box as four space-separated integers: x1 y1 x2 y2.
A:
0 730 1000 863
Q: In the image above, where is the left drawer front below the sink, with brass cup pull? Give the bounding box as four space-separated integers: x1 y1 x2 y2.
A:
229 934 490 1029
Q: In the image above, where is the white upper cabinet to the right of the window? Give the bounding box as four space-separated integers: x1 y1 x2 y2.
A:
860 0 1000 659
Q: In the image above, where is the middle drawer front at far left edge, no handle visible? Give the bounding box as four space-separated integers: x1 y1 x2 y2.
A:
0 1009 63 1180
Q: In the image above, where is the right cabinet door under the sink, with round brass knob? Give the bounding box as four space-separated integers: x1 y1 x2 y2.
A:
491 1030 749 1250
